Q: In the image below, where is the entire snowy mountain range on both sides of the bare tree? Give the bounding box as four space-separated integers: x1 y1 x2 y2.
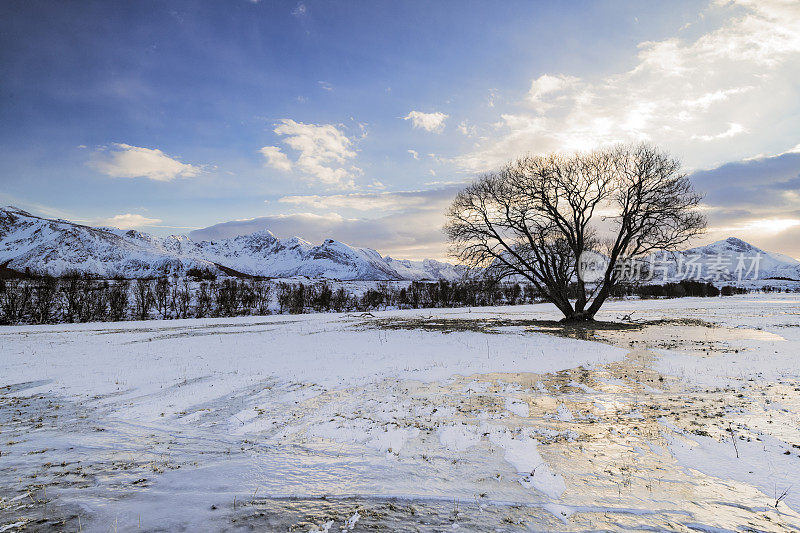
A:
0 207 800 282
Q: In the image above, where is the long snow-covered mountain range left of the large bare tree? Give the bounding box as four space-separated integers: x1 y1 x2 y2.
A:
0 207 463 280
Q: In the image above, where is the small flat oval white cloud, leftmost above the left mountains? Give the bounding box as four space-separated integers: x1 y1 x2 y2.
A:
89 143 200 181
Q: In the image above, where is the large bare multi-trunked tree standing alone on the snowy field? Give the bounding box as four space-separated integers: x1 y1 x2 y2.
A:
445 144 706 321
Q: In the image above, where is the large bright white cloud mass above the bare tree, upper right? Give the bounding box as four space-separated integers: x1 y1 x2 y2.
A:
460 0 800 172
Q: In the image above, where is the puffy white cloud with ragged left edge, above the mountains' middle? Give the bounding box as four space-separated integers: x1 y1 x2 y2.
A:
259 119 361 189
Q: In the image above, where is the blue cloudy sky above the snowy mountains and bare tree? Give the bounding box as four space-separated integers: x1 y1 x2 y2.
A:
0 0 800 258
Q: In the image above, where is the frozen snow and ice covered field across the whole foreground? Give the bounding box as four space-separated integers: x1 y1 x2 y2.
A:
0 295 800 531
